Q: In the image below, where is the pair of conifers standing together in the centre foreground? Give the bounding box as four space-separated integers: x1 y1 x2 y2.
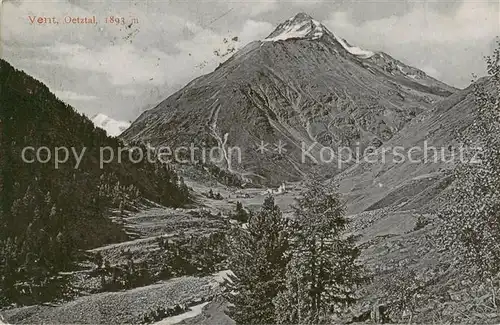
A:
227 181 369 324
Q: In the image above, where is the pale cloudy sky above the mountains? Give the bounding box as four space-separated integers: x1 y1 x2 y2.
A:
0 0 500 121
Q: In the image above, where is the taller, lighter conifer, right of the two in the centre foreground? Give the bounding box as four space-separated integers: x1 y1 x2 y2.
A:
275 180 368 324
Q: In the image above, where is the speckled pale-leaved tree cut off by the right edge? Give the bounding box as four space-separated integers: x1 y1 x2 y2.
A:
438 42 500 307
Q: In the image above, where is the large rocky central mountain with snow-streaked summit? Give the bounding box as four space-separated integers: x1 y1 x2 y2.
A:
122 14 456 183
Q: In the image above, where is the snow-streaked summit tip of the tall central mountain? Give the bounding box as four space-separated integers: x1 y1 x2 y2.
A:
263 13 325 42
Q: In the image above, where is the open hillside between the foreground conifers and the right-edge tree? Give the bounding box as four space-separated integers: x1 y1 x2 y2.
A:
334 78 498 324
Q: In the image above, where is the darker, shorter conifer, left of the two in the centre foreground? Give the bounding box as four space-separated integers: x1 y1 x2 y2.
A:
227 197 288 324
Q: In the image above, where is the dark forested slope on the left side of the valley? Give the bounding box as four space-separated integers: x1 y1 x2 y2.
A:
0 60 190 304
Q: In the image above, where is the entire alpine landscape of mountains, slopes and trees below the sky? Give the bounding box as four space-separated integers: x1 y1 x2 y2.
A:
0 13 500 325
